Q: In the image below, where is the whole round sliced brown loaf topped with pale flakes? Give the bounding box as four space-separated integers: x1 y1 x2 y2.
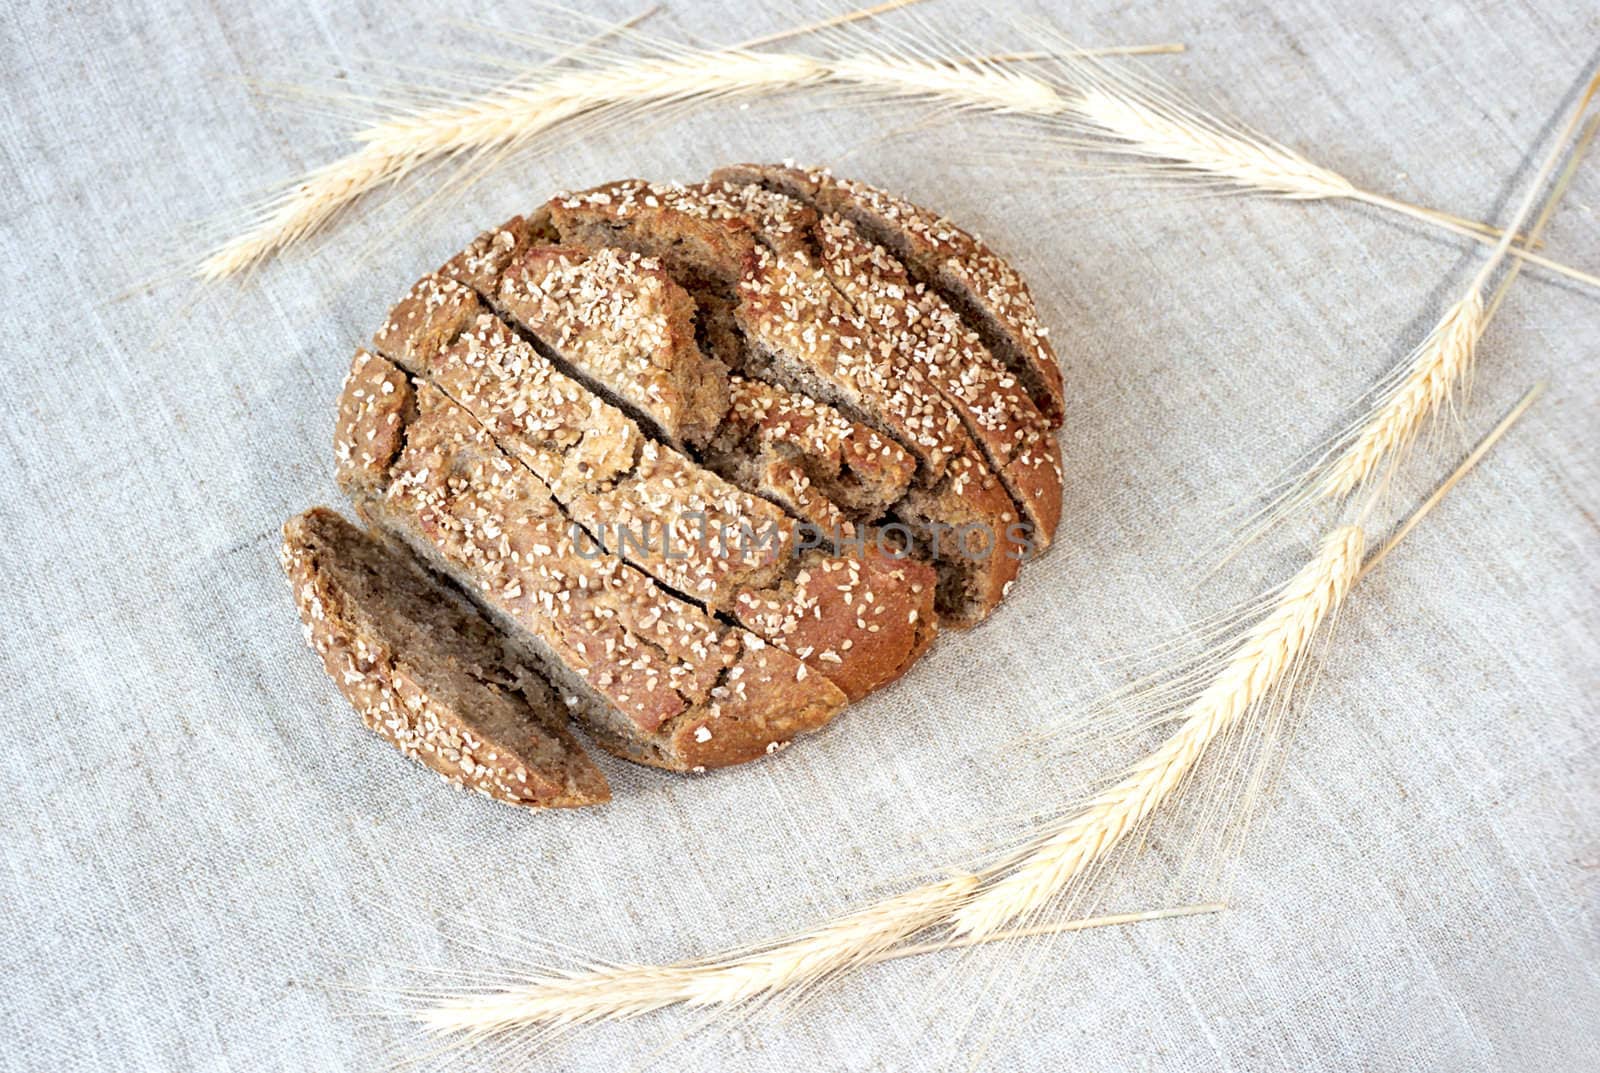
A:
285 165 1064 806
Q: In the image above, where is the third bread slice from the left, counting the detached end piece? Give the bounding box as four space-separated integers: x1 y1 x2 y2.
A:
374 275 936 699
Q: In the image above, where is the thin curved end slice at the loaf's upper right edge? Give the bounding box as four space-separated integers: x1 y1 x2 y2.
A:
712 165 1066 429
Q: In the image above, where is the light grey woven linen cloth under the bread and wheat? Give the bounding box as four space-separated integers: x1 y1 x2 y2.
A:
0 0 1600 1071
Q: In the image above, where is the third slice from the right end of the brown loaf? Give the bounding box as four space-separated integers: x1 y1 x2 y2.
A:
549 181 1022 625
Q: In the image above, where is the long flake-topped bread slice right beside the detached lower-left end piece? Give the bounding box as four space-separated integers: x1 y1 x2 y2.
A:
336 352 845 771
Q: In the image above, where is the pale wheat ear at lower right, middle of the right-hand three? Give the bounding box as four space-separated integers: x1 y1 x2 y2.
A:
950 526 1365 937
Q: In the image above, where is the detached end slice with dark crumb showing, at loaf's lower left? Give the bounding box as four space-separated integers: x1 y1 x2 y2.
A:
280 507 611 808
